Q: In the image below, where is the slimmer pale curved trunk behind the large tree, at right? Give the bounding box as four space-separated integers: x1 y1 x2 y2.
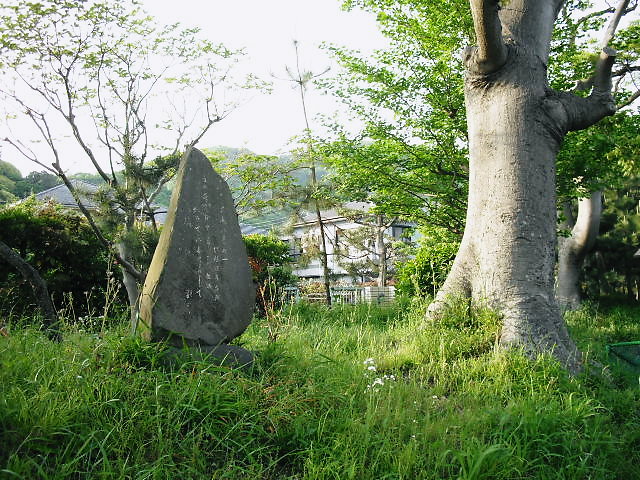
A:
556 191 602 310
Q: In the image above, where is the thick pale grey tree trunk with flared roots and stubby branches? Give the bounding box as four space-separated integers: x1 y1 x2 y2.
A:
428 0 615 372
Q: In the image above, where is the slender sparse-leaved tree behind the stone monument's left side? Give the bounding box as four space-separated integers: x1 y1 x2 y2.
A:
0 0 256 322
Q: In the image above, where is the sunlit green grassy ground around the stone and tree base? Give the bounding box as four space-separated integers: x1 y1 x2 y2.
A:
0 304 640 480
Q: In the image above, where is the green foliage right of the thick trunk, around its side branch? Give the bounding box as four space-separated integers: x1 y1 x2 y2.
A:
549 0 640 201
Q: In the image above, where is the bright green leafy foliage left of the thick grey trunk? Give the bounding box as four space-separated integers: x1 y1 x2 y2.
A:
324 0 472 234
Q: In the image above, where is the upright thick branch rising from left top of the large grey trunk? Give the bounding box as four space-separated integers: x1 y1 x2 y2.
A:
467 0 507 74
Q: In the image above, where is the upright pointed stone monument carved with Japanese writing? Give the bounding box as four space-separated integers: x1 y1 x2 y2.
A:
138 149 255 347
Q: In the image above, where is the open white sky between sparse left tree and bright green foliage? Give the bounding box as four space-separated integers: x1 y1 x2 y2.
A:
144 0 383 154
